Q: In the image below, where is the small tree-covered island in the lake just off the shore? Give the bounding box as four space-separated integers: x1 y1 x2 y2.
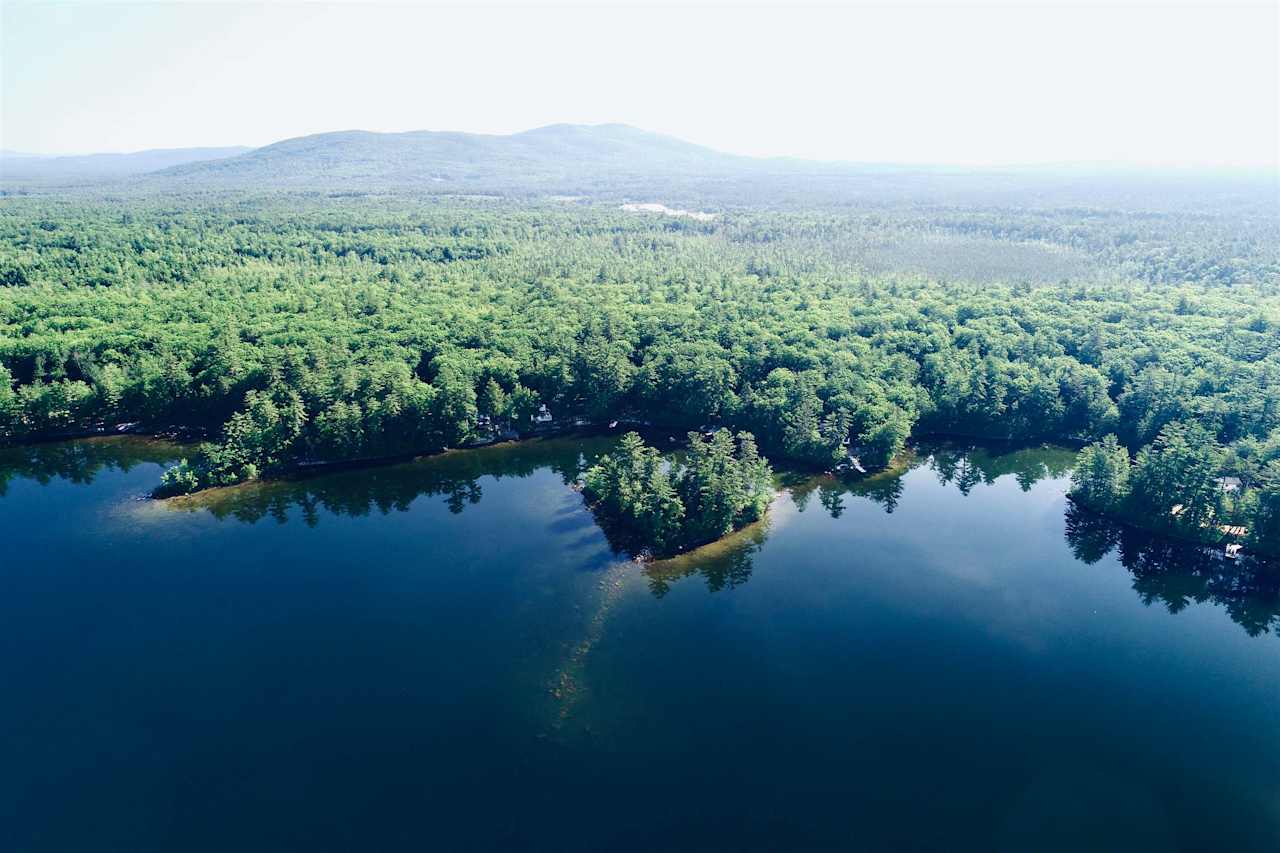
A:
582 429 774 557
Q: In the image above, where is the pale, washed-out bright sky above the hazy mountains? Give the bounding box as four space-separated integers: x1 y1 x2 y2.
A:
0 0 1280 169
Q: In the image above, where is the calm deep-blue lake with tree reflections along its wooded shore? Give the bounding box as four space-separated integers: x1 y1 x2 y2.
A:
0 438 1280 853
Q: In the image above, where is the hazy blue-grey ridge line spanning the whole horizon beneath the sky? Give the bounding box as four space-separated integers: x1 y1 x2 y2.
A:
0 124 1276 216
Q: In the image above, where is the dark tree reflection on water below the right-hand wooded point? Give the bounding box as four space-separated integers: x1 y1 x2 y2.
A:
1066 503 1280 637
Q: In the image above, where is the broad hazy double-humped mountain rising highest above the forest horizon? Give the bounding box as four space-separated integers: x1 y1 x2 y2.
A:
156 124 751 190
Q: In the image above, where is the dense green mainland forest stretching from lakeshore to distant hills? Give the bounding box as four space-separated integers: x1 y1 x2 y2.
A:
0 184 1280 552
